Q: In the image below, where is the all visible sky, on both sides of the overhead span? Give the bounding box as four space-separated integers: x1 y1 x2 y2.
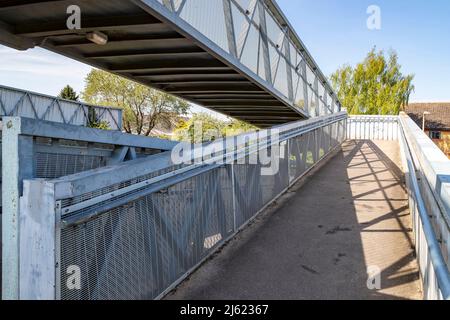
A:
0 0 450 101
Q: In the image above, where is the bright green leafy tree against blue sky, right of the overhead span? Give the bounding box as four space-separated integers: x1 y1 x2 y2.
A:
331 48 414 115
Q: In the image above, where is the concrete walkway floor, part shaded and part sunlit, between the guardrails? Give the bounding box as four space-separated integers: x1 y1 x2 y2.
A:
166 141 421 300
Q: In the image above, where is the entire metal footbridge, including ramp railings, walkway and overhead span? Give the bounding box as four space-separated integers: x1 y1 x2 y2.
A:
0 0 450 300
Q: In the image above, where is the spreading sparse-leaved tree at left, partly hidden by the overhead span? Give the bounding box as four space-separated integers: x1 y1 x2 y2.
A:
83 70 190 136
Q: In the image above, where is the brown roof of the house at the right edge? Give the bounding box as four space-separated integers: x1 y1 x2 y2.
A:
406 102 450 131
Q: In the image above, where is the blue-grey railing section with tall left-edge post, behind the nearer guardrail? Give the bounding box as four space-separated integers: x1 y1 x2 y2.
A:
0 117 176 299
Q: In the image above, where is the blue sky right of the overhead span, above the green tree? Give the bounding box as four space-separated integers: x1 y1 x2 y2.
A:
278 0 450 101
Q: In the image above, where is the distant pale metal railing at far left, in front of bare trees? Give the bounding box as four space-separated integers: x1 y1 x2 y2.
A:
0 85 122 130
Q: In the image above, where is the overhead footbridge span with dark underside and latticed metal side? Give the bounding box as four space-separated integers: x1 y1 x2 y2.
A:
0 0 340 127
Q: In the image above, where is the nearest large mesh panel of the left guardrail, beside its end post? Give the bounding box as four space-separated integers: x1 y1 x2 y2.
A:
61 168 233 299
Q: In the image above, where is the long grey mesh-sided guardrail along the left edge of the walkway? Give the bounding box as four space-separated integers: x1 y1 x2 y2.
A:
13 113 347 299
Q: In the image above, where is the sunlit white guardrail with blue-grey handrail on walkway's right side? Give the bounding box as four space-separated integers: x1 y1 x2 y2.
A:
399 114 450 300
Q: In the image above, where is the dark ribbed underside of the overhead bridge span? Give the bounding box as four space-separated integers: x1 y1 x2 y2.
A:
0 0 306 127
